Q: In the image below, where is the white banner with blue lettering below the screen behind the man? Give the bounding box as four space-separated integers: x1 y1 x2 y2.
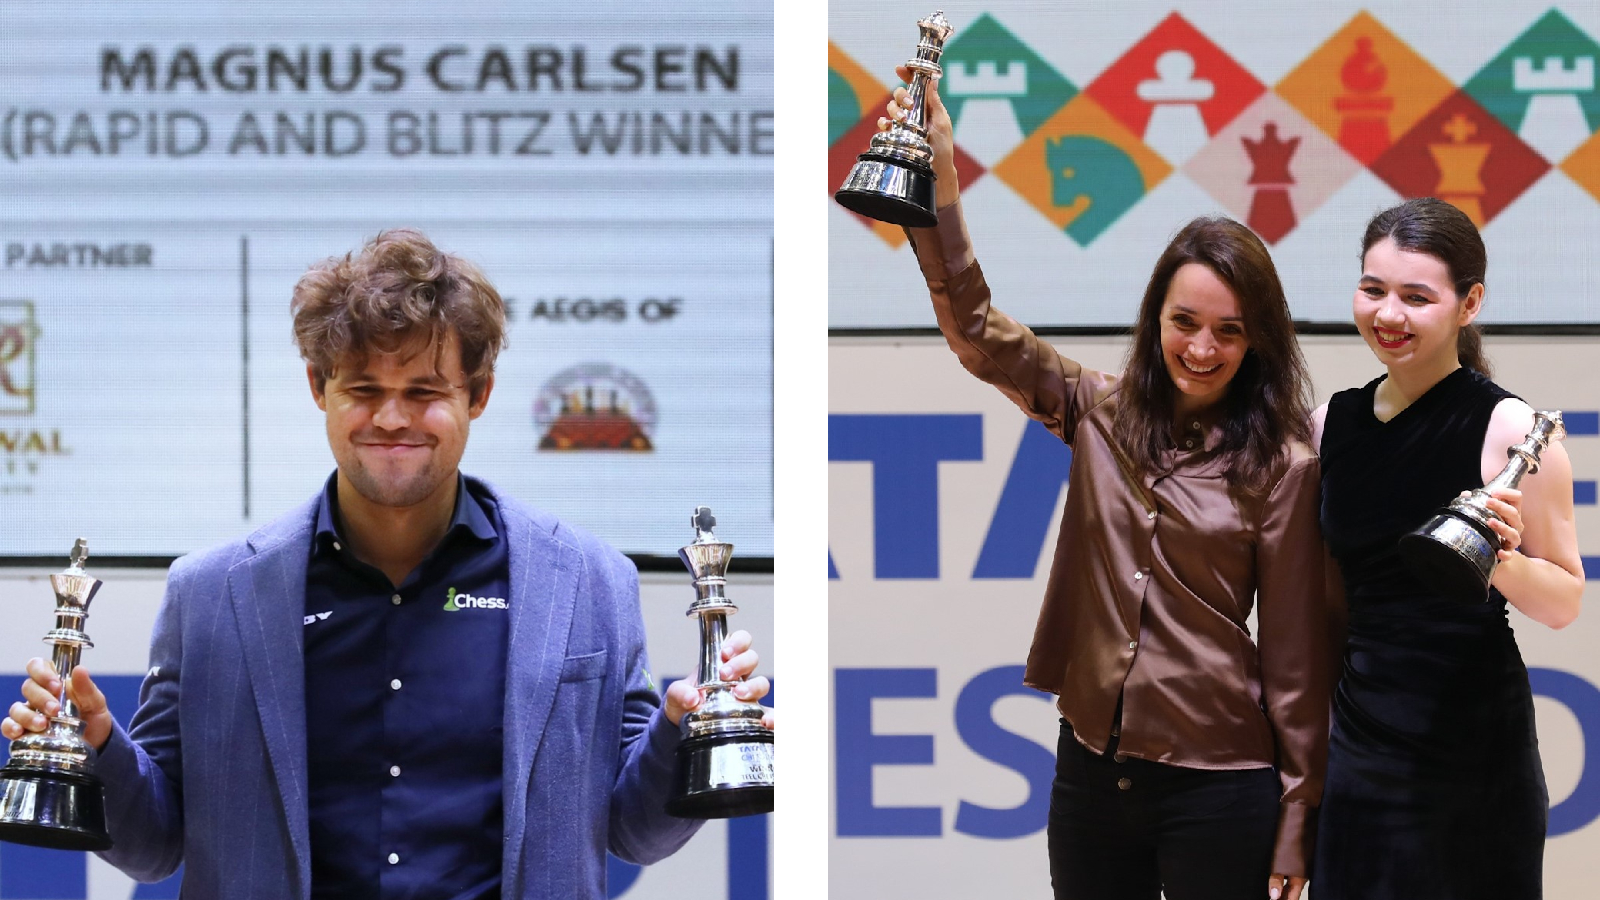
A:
0 566 779 900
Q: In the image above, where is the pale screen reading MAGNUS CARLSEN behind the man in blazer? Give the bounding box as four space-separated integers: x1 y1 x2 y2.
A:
0 0 774 560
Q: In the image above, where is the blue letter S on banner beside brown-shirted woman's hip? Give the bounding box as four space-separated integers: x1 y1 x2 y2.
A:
955 666 1056 839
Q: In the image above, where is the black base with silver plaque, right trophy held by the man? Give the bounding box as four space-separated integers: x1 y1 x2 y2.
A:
667 729 773 818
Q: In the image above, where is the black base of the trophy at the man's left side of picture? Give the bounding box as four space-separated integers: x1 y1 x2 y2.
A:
0 765 110 850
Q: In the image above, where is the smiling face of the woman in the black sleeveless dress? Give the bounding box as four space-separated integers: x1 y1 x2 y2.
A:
1354 237 1483 370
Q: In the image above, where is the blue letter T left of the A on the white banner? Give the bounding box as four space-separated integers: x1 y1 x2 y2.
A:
827 413 984 578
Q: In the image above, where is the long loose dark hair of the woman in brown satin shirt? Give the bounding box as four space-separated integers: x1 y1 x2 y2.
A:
1112 218 1310 493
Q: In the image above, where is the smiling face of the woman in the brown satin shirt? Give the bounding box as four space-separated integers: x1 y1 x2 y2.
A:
1162 263 1250 413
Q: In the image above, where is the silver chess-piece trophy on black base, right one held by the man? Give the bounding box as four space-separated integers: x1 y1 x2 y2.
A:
667 506 773 818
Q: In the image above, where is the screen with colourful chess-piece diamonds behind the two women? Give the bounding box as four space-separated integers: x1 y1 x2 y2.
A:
827 0 1600 328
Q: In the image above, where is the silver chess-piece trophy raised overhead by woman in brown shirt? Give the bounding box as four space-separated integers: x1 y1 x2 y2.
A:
834 11 952 227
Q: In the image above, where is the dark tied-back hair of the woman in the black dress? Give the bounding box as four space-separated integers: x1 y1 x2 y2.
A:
1362 197 1493 378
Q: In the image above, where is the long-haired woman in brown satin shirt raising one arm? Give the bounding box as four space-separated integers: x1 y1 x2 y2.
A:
880 69 1330 900
